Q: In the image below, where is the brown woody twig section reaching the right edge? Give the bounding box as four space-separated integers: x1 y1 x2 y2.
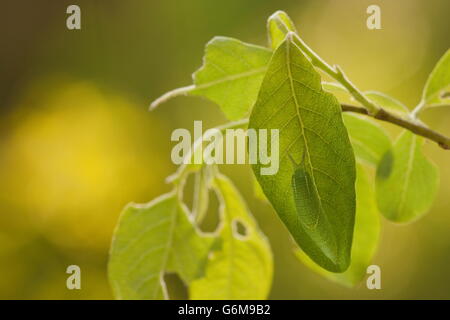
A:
341 104 450 150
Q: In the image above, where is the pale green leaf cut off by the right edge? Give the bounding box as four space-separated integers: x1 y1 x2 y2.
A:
422 49 450 105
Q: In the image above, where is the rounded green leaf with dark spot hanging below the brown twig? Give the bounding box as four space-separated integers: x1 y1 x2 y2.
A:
376 131 439 222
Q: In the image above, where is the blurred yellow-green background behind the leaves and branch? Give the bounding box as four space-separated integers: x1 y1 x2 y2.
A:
0 0 450 299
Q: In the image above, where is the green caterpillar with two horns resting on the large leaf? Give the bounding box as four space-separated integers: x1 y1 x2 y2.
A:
289 154 322 229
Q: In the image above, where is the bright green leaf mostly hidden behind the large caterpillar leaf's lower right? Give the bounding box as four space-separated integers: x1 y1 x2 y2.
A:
295 164 380 287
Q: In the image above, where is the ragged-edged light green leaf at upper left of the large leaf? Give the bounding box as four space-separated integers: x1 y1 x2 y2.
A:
189 37 272 120
